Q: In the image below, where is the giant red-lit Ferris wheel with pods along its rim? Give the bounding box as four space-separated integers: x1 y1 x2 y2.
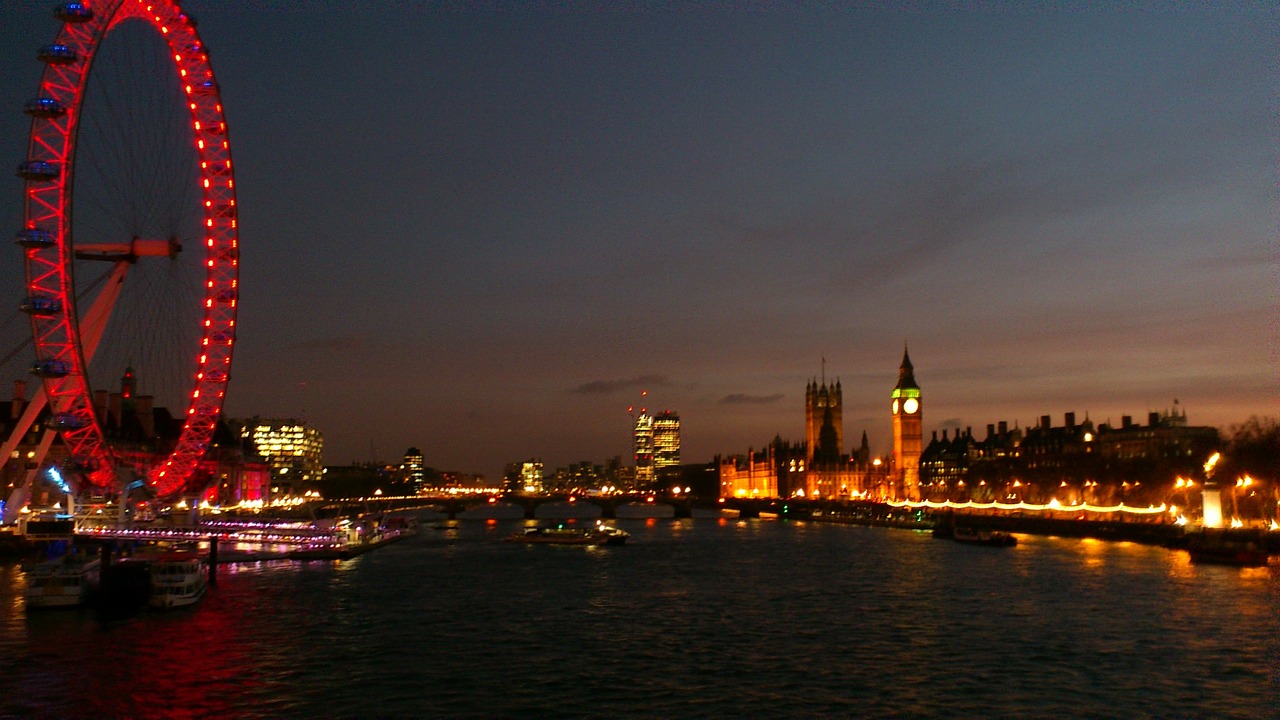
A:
15 0 239 497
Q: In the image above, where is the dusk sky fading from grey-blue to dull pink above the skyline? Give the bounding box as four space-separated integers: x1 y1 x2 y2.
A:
0 0 1280 478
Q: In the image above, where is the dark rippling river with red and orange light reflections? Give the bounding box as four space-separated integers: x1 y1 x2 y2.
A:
0 519 1280 719
